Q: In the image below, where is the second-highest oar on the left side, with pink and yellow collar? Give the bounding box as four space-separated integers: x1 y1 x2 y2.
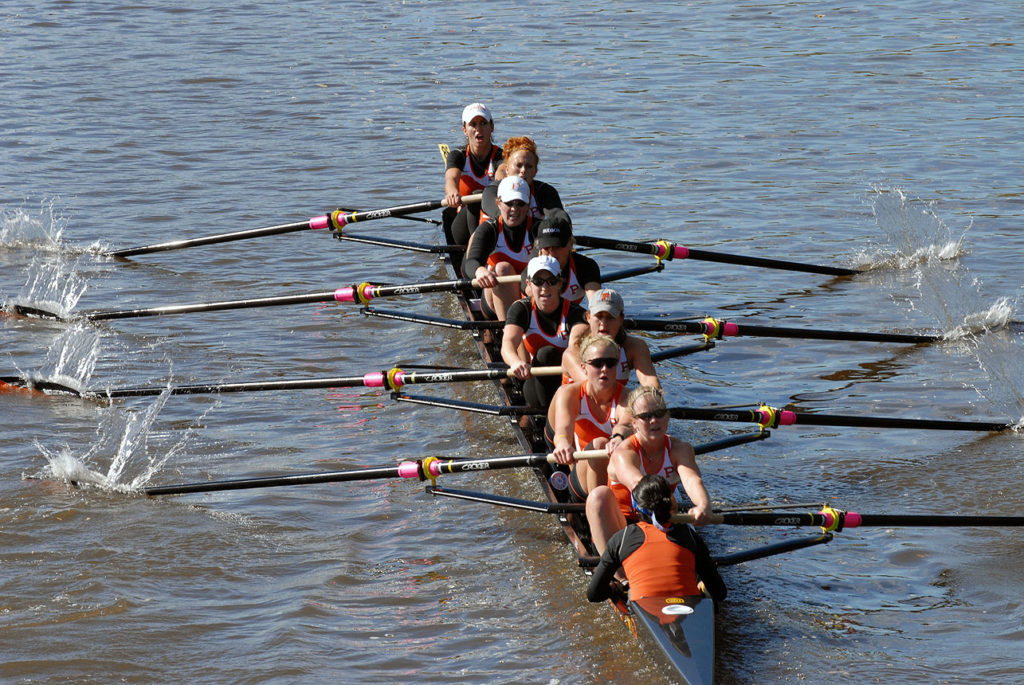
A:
13 275 520 322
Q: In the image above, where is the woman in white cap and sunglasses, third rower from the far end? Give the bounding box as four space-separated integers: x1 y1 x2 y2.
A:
462 176 536 317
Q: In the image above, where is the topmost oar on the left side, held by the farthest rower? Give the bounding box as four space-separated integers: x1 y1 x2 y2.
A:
103 194 481 257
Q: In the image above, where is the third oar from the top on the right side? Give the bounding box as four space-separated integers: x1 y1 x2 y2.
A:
669 404 1014 432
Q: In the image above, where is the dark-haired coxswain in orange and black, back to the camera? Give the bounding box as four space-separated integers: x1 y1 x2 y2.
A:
587 473 727 602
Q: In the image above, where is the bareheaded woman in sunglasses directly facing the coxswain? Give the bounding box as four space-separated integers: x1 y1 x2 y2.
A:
587 385 711 553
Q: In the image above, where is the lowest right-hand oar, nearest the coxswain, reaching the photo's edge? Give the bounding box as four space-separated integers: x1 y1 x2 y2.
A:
672 507 1024 532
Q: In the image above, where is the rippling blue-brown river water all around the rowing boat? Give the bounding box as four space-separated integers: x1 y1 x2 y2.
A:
0 1 1024 683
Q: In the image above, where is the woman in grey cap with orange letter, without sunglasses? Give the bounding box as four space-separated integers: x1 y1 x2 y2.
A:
562 288 662 388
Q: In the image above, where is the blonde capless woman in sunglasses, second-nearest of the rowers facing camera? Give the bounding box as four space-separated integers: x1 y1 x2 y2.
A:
544 335 631 502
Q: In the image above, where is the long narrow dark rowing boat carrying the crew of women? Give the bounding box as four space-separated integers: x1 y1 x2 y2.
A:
423 231 720 685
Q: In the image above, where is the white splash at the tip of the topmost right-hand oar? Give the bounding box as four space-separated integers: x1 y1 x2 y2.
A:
856 186 971 269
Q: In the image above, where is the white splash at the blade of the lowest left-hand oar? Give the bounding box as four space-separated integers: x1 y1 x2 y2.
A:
35 391 219 494
